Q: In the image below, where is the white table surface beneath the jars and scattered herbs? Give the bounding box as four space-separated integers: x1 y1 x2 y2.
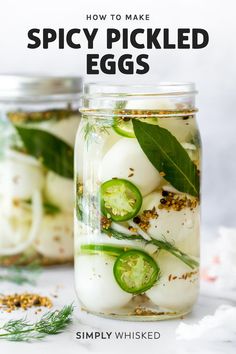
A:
0 267 236 354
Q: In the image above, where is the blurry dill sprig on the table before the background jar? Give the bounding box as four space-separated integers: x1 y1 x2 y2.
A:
0 264 42 285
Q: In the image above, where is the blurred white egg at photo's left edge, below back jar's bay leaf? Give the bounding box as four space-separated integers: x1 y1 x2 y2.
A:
0 158 44 199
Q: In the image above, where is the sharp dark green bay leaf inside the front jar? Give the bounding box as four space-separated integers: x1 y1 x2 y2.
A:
133 119 200 197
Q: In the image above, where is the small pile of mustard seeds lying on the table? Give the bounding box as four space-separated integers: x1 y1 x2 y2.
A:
0 293 52 312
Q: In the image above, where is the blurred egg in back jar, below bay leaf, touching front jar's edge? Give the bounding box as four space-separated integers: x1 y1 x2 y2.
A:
45 171 74 212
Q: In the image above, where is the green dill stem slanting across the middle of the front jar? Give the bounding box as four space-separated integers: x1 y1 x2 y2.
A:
102 228 199 269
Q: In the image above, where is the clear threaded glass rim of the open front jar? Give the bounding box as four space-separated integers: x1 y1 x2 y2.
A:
80 82 197 117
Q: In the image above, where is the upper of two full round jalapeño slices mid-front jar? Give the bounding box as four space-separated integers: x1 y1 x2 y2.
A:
101 178 142 221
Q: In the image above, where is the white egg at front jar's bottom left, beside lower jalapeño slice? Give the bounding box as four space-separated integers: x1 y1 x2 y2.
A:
75 255 132 312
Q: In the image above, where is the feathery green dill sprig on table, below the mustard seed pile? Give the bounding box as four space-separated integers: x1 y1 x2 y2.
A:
0 304 74 342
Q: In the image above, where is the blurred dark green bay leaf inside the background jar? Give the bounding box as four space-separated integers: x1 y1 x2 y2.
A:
15 125 74 178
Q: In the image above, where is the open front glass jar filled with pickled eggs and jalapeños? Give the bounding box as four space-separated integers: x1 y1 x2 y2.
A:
75 83 201 321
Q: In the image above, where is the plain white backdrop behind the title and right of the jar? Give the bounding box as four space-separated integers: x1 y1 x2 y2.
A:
0 0 236 230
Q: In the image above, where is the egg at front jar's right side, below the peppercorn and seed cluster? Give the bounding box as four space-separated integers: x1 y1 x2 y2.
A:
141 192 200 256
